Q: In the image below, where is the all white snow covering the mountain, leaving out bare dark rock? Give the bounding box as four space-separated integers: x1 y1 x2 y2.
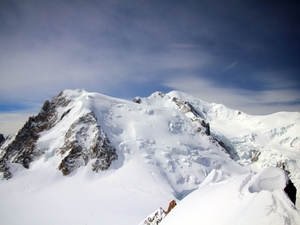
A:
0 90 300 225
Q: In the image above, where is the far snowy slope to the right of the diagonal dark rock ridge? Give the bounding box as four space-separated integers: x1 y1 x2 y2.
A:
164 92 300 208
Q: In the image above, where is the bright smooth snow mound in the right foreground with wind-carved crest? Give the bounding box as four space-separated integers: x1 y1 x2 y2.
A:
161 167 300 225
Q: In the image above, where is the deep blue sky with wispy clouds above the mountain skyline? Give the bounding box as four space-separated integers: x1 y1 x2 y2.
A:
0 0 300 134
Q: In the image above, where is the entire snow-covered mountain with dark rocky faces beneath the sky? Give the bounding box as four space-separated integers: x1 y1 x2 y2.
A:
0 90 300 224
